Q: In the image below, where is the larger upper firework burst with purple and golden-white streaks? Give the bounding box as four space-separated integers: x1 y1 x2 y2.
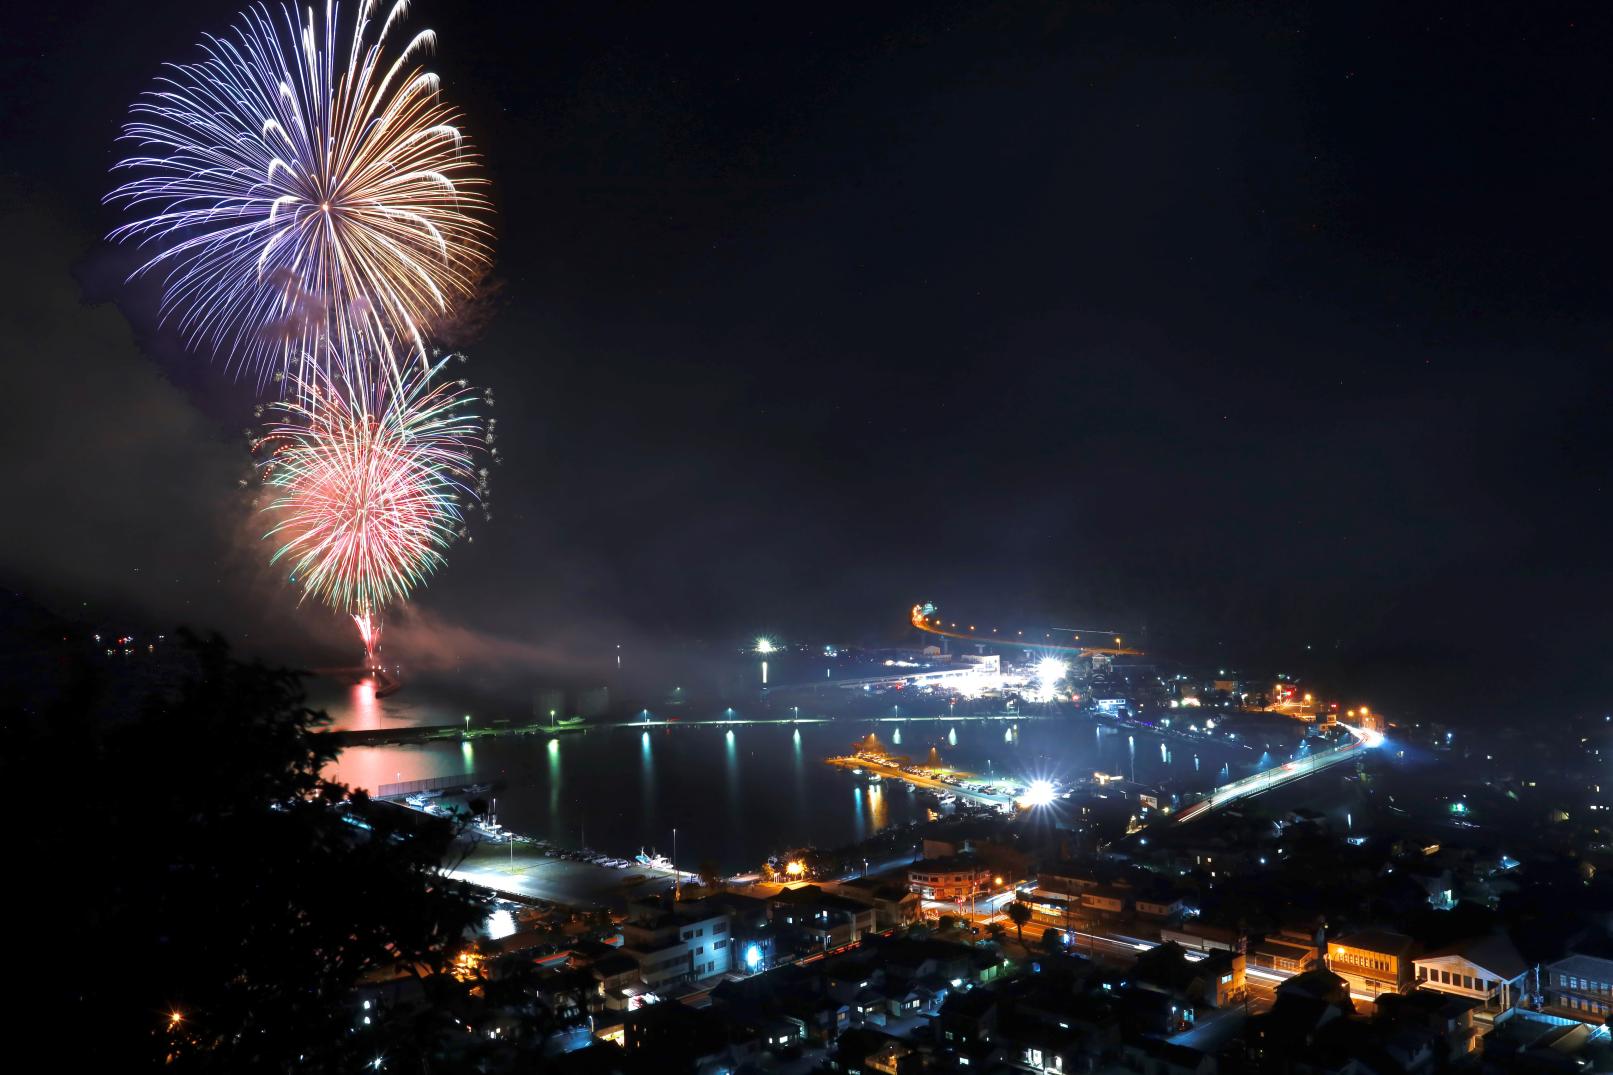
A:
106 0 490 384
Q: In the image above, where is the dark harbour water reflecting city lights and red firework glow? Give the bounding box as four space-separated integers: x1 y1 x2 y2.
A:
324 677 1286 872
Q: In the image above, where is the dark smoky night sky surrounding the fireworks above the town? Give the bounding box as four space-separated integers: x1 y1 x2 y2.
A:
0 0 1613 713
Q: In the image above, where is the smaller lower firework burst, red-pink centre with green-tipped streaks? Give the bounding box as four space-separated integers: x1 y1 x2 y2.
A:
255 347 497 665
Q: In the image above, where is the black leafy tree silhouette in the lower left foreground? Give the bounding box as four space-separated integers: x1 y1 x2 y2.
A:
0 628 481 1072
